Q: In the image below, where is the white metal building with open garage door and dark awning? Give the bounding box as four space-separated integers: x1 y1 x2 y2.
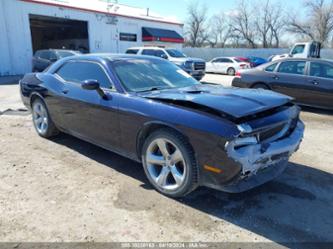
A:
0 0 183 76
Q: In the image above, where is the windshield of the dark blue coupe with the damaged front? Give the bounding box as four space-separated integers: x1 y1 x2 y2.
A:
113 59 200 92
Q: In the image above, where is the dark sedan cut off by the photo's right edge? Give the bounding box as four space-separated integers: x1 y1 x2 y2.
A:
232 59 333 110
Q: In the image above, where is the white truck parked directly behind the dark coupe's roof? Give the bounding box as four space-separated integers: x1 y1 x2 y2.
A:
126 47 206 80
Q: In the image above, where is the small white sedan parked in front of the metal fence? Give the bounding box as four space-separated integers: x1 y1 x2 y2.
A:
206 57 251 75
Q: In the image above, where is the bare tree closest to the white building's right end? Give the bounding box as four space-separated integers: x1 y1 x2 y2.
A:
185 1 208 47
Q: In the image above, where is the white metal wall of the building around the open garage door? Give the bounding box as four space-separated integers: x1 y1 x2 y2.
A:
0 0 183 76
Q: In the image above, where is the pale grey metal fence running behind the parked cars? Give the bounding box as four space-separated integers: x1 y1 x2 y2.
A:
183 48 333 61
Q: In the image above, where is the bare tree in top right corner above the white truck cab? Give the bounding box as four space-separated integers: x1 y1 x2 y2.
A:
288 0 333 45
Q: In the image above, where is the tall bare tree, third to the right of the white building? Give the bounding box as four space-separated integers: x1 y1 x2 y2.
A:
230 0 257 48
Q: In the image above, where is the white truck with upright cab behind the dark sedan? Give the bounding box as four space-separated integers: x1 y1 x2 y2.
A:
271 41 321 61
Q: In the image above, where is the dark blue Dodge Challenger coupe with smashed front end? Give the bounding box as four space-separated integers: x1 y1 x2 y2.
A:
20 54 304 197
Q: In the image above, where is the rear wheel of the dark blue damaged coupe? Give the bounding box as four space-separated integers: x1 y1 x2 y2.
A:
32 98 59 138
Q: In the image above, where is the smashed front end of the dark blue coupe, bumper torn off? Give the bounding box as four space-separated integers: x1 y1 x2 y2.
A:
222 106 304 192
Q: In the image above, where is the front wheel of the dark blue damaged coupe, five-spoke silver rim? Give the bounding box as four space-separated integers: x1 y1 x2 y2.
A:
142 129 198 198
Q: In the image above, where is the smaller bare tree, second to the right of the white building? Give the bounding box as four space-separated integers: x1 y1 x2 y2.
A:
209 13 232 48
